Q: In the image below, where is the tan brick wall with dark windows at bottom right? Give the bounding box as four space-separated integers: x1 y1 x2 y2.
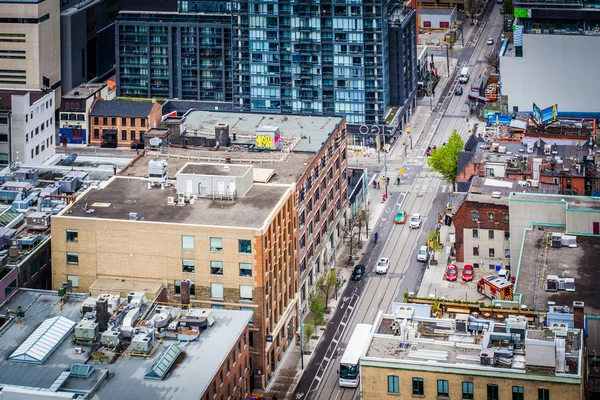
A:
360 364 583 400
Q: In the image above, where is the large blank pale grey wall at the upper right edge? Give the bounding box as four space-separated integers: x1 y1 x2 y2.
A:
500 34 600 113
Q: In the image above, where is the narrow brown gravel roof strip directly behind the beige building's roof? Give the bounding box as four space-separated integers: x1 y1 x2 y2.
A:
119 149 314 184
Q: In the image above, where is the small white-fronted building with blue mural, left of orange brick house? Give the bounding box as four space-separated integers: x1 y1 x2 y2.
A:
58 83 116 146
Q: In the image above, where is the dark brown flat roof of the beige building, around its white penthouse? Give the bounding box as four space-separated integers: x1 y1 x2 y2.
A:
59 176 291 229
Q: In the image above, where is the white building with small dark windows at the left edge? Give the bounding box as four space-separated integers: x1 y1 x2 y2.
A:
0 90 56 164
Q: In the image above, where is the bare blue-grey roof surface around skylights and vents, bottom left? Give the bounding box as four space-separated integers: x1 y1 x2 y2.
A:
0 290 252 400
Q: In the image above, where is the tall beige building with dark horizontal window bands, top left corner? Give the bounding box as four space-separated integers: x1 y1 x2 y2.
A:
0 0 61 108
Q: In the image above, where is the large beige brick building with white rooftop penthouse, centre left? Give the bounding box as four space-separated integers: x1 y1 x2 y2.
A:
52 164 298 387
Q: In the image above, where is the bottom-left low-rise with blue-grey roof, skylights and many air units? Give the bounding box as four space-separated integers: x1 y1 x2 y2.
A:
0 290 251 400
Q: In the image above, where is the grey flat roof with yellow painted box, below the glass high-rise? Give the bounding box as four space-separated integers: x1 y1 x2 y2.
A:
184 110 344 153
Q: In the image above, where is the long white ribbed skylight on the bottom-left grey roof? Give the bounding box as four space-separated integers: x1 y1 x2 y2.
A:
8 316 75 364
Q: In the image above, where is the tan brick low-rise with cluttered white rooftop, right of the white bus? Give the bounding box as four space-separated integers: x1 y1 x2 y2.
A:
360 304 585 400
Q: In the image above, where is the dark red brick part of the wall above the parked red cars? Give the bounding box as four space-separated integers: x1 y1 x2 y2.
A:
452 201 510 262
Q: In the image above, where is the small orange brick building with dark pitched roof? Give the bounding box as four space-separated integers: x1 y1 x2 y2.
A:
89 100 162 148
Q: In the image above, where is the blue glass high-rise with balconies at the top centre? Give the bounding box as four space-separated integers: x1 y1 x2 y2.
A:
117 0 417 124
